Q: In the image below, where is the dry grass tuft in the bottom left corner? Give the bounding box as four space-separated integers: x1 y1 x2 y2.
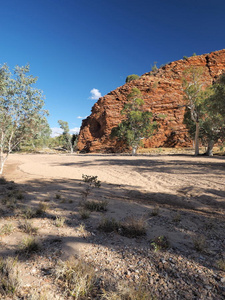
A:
0 257 20 299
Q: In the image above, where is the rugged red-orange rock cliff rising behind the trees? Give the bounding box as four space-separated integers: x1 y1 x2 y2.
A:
78 49 225 152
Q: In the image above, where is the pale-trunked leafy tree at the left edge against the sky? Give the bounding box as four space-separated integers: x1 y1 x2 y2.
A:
0 64 48 174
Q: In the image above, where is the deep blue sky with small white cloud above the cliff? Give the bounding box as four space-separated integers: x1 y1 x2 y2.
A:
0 0 225 136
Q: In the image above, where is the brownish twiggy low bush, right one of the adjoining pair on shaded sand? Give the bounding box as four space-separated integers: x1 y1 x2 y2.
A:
119 216 146 238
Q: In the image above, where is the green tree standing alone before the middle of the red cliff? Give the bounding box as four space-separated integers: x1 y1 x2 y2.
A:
111 88 157 155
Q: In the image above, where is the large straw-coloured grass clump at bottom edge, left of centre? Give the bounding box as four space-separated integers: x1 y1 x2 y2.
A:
53 259 96 300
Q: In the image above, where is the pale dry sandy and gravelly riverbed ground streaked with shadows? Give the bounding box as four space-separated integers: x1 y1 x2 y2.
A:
0 154 225 299
